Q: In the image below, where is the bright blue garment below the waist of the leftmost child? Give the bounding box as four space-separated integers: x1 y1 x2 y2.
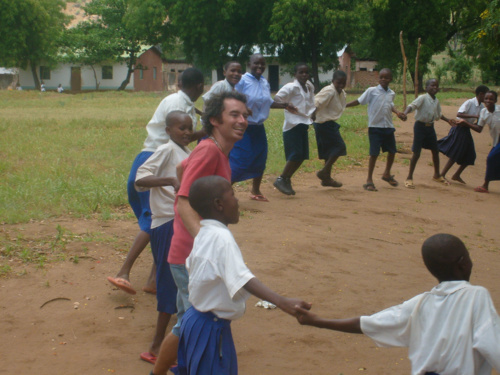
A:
127 151 153 234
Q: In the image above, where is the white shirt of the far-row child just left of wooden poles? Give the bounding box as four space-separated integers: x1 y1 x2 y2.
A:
358 85 396 128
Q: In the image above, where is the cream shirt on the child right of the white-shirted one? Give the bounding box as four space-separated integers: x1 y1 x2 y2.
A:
314 83 347 124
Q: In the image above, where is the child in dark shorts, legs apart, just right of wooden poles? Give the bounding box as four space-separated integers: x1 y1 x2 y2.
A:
404 79 456 189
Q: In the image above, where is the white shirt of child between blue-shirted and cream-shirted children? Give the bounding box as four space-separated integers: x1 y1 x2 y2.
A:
274 79 314 132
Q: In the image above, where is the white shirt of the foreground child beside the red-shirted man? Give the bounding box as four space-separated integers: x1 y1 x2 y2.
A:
186 219 255 320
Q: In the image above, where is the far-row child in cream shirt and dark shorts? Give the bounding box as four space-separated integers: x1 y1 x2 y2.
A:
313 70 347 187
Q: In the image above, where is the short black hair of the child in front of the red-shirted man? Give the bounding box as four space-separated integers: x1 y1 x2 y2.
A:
189 175 231 219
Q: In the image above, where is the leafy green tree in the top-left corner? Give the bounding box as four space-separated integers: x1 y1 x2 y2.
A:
0 0 69 89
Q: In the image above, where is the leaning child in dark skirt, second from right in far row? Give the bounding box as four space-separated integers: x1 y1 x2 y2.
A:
438 85 489 184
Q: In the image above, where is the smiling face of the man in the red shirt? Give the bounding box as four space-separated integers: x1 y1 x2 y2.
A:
211 98 248 143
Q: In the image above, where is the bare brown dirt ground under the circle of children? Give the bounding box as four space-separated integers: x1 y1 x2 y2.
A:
0 101 500 375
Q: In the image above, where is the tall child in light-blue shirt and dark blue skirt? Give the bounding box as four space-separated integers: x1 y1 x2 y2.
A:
233 53 295 202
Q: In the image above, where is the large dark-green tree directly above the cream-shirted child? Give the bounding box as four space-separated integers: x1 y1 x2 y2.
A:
269 0 362 90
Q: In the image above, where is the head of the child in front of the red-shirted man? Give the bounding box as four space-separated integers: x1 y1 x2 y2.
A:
189 176 240 225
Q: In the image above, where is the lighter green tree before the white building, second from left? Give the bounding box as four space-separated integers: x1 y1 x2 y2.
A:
84 0 153 90
